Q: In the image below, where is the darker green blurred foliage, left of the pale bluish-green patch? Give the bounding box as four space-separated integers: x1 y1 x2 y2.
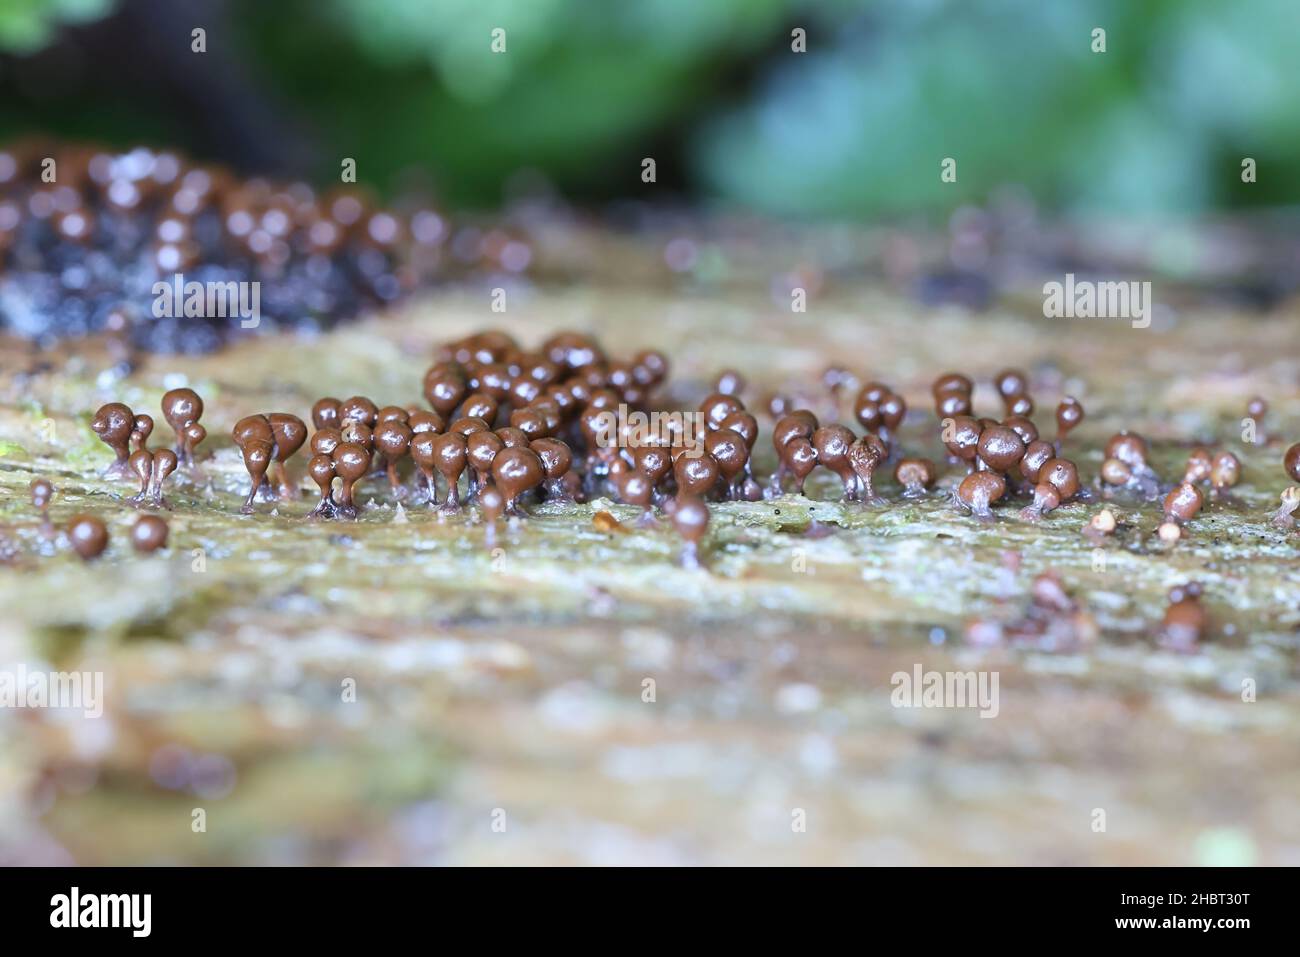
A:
239 0 788 203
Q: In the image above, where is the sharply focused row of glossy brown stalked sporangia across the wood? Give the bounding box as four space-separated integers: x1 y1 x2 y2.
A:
81 332 1300 579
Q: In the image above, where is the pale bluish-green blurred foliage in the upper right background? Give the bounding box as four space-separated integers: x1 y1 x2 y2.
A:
692 0 1300 213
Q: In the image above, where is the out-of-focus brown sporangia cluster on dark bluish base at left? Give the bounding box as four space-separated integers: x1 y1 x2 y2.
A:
0 140 527 352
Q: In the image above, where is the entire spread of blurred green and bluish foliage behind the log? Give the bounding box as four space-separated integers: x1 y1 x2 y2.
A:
0 0 1300 217
